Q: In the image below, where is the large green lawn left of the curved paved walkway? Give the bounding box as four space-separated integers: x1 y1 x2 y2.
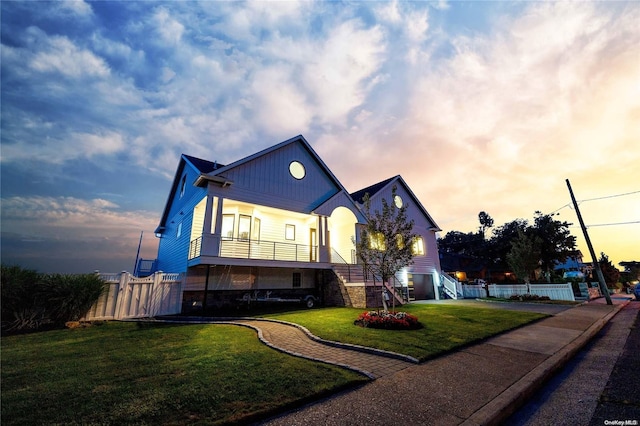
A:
1 322 367 425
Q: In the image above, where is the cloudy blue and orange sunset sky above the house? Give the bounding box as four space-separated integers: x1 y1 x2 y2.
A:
0 1 640 272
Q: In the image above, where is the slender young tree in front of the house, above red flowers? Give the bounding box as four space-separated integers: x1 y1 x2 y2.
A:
354 186 417 308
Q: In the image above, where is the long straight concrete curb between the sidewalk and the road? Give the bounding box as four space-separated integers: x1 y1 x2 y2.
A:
461 302 628 426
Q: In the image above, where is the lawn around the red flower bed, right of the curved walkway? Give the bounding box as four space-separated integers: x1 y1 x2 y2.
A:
265 304 547 361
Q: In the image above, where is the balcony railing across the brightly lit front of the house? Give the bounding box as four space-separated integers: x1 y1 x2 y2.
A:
188 235 318 262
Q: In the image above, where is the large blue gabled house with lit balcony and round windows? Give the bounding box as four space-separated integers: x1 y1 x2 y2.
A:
142 136 440 308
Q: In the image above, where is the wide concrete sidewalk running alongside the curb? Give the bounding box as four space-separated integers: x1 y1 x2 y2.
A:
258 298 629 426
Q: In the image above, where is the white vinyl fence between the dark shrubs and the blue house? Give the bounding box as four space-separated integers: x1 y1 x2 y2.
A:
82 272 183 321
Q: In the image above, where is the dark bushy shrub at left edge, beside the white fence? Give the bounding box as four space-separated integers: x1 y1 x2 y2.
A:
0 265 105 332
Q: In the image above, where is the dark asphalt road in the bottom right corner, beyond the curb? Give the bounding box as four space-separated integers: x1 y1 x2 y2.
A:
505 301 640 426
